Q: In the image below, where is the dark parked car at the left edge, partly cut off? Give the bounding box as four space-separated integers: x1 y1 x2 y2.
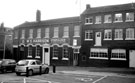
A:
0 59 16 73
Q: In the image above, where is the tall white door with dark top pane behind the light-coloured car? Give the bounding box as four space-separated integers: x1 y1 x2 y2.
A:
43 47 50 65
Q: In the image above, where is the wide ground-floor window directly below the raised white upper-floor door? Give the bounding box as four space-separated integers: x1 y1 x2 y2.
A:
90 48 108 59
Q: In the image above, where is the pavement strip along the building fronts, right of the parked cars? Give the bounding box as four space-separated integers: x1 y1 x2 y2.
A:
50 66 135 78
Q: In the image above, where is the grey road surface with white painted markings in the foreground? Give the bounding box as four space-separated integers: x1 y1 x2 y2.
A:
0 72 135 83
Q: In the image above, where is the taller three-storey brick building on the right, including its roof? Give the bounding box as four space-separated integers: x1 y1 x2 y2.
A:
79 3 135 67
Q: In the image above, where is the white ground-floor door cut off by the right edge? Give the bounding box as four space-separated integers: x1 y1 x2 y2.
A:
129 50 135 68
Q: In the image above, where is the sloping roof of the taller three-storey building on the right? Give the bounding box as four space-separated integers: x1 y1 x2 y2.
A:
82 3 135 15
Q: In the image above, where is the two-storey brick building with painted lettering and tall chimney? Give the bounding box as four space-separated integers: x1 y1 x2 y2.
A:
13 10 81 65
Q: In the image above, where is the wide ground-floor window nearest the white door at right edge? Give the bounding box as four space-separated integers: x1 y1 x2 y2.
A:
111 49 126 60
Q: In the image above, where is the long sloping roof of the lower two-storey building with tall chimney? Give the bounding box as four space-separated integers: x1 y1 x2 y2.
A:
14 16 80 28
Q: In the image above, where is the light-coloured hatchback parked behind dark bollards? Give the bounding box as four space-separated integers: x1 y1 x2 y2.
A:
15 59 49 76
